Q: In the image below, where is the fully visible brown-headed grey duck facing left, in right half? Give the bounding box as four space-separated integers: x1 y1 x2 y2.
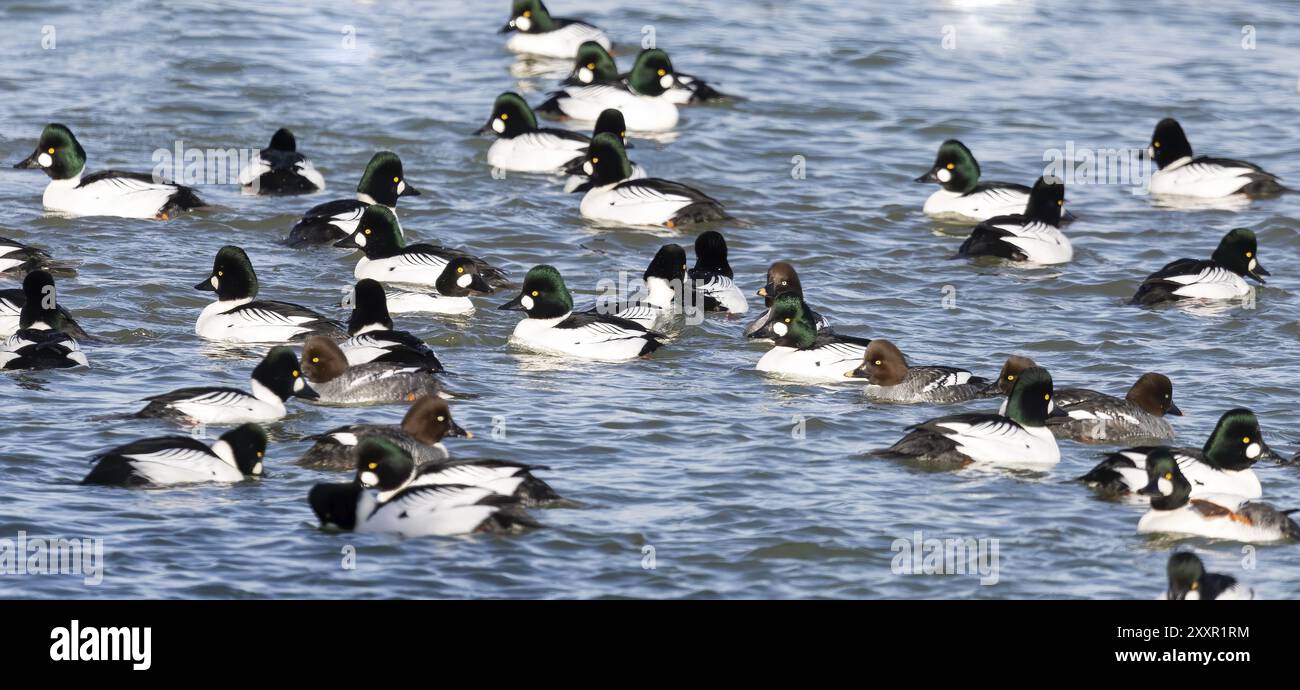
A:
844 338 989 403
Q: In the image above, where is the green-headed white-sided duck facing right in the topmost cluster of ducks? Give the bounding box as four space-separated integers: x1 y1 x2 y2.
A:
536 48 680 133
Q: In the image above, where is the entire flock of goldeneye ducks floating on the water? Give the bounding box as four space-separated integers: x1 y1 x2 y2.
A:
0 0 1300 598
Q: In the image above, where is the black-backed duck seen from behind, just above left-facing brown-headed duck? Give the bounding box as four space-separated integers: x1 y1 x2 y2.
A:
338 278 447 372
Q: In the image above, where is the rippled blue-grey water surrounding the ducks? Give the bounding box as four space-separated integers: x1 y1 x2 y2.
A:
0 0 1300 598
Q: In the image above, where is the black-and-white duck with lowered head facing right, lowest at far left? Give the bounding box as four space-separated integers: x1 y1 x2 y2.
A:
81 424 267 486
